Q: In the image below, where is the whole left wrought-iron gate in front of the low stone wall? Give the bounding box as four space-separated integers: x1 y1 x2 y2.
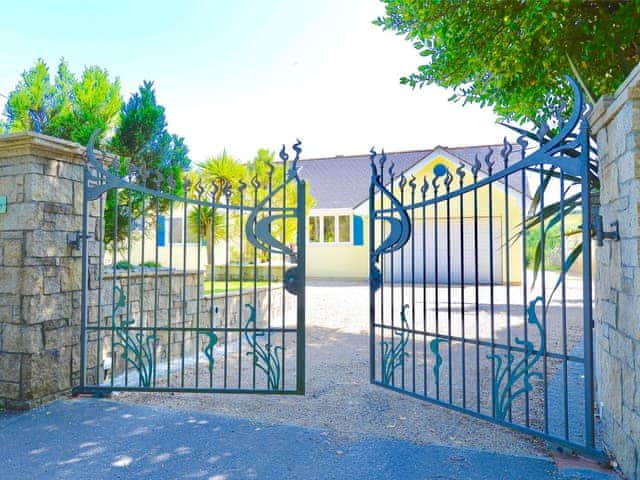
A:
75 138 306 394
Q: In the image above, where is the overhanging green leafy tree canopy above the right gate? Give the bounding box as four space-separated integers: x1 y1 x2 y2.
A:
374 0 640 121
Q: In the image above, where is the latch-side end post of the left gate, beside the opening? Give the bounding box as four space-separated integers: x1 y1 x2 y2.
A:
296 181 307 394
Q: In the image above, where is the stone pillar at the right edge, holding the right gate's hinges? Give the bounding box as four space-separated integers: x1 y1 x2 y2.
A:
590 65 640 478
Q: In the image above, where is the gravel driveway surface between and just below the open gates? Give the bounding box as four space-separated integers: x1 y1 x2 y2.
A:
114 282 568 455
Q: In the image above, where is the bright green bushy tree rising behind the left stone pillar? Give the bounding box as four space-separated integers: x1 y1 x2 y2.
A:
5 59 122 144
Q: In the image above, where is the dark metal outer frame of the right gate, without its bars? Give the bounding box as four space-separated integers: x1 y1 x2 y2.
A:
369 77 612 461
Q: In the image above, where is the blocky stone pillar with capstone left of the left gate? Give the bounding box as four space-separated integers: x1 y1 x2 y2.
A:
0 132 95 409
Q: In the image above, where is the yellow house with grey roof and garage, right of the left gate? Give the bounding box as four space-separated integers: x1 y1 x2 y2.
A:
300 145 529 284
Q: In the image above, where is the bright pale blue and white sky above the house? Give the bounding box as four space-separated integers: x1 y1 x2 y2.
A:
0 0 508 163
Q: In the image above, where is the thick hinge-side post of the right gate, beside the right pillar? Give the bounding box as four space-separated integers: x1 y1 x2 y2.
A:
579 119 595 448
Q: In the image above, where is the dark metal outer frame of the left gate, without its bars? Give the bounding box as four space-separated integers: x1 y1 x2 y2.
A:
72 134 307 396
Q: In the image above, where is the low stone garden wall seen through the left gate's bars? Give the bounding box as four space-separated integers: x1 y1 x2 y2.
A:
87 268 295 384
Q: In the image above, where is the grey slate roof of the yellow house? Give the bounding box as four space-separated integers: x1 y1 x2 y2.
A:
298 144 523 208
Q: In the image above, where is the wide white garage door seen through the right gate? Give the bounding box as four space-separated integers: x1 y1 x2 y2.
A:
385 217 504 284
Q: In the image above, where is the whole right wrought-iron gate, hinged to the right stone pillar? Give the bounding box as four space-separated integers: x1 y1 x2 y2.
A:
369 81 600 456
